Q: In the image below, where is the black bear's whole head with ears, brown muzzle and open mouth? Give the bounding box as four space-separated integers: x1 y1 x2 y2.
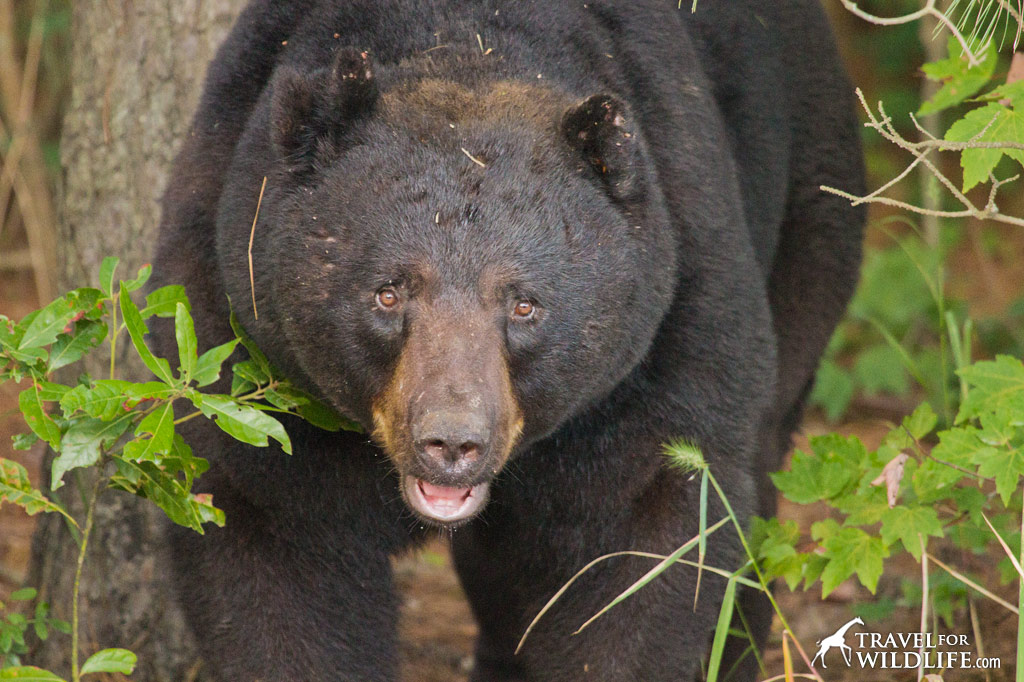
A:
252 50 675 524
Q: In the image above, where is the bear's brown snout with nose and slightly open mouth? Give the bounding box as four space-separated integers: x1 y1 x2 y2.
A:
374 307 522 524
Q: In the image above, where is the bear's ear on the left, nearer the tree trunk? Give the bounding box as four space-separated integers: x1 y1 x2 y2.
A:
270 47 377 166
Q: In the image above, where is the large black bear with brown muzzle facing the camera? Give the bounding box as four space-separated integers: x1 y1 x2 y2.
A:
151 0 863 682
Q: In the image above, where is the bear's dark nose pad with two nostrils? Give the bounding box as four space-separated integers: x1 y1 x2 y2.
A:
412 412 490 476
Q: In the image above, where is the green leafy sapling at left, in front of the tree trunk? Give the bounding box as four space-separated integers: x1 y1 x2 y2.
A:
0 258 359 682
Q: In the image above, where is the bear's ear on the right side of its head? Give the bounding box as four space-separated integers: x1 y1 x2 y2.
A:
561 94 642 201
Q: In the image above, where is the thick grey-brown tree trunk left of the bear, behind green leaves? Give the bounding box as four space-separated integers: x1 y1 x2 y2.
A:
30 0 244 682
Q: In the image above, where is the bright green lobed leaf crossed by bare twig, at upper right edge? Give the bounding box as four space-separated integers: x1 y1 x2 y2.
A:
946 102 1024 191
